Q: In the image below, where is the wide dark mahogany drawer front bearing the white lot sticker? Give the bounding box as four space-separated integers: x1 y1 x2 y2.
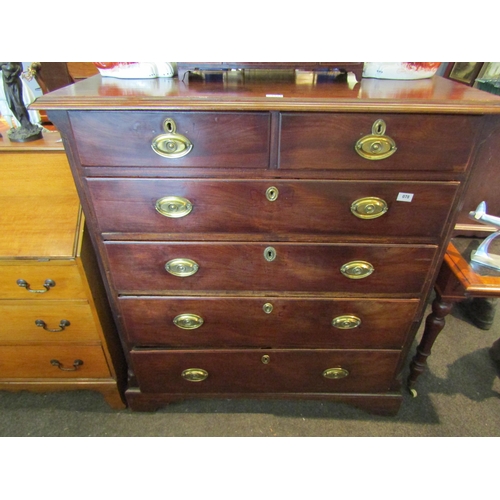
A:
87 178 458 239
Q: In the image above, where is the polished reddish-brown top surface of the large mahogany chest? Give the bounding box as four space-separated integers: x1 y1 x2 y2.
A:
30 71 500 114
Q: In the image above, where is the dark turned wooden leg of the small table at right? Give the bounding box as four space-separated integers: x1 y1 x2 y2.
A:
408 292 453 397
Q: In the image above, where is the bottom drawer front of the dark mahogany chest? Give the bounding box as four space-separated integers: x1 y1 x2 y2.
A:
131 349 399 393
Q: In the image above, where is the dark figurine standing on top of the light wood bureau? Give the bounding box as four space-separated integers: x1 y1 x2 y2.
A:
0 62 42 142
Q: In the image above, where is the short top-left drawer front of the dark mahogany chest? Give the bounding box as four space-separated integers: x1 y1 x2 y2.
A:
69 111 270 169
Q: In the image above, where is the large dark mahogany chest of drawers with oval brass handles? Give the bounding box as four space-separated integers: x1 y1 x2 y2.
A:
36 71 500 414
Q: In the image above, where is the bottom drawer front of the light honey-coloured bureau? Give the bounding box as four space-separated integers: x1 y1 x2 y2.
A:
0 345 110 379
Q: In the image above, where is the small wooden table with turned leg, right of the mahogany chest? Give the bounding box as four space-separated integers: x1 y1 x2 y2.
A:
408 237 500 397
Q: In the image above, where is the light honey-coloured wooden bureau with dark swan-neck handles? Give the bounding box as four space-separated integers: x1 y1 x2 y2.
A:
0 120 125 408
